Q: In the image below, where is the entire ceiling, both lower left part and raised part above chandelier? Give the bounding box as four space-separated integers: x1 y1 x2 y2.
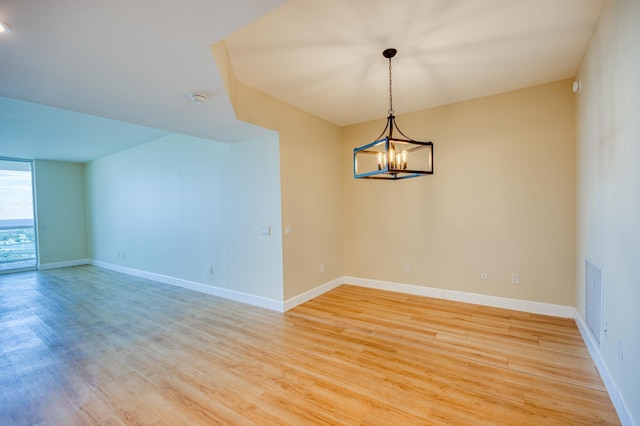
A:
0 0 604 162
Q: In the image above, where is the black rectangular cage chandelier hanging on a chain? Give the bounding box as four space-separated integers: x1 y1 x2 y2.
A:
353 49 433 180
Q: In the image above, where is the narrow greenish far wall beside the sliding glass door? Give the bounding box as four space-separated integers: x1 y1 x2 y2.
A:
33 160 88 267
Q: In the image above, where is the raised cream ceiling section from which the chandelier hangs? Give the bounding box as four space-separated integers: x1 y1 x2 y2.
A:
226 0 604 126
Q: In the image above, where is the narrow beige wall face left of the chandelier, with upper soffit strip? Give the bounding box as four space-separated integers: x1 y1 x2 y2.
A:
212 42 343 300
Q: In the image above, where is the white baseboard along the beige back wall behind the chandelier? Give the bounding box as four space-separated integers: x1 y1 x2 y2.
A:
344 277 575 318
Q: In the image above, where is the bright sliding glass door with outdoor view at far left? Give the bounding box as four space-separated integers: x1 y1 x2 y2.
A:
0 158 37 273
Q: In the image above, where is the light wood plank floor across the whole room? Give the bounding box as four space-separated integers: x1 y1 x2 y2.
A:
0 266 619 425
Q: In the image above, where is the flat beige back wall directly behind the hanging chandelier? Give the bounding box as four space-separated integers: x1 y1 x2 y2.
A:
342 80 575 305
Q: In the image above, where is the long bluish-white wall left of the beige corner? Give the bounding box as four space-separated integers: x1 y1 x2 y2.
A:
87 134 282 300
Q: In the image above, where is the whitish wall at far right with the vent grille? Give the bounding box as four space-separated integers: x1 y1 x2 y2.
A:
576 0 640 423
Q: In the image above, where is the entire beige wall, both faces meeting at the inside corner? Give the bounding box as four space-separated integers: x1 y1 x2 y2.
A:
213 34 575 305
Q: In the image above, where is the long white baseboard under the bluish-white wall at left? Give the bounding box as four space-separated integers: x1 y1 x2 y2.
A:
91 260 284 312
